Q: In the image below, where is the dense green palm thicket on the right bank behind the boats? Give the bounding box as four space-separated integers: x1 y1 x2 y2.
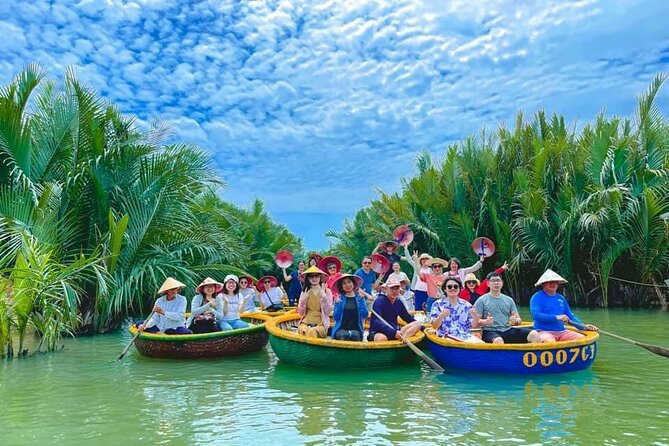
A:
327 76 669 309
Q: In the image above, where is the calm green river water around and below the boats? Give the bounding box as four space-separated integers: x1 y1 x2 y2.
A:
0 309 669 446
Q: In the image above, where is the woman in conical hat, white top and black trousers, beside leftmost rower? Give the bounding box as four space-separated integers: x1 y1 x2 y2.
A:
186 277 223 333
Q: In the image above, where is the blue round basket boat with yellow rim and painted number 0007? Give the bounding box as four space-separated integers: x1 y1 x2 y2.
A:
426 329 599 375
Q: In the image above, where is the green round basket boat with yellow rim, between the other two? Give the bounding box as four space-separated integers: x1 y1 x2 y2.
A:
266 313 425 369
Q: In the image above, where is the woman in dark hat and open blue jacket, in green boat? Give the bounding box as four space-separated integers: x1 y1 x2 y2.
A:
332 274 369 341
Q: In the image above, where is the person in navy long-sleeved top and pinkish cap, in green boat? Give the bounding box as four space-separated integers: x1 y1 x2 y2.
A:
367 280 421 342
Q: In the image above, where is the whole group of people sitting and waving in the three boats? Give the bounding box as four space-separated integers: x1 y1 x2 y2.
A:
137 241 597 344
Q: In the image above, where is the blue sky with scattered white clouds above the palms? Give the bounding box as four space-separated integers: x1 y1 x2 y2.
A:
0 0 669 248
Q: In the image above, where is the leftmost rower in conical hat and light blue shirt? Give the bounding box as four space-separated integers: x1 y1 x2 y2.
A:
137 277 193 335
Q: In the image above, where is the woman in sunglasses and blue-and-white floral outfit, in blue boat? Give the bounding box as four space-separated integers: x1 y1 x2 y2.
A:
430 277 483 344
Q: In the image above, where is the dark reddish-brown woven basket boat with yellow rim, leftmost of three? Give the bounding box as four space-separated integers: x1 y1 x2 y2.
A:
129 313 269 359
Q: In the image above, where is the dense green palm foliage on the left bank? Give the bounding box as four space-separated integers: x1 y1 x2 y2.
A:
0 65 302 354
